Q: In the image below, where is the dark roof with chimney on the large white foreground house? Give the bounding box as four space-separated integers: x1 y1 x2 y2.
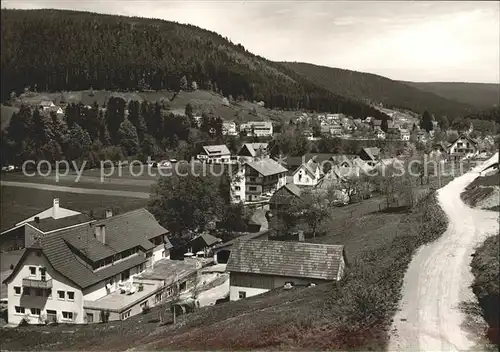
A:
2 209 172 288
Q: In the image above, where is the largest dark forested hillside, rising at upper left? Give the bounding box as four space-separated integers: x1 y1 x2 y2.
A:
1 10 385 119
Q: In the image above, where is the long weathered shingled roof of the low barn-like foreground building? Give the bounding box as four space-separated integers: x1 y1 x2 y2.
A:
226 240 344 280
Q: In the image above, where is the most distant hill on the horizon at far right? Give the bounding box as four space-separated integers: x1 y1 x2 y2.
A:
402 82 500 108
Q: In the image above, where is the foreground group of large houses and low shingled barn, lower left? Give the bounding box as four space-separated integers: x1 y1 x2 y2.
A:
0 199 347 325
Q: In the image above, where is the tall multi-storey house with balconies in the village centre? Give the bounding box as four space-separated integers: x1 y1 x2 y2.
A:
244 158 288 202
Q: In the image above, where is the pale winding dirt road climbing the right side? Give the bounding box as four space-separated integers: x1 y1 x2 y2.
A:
389 154 498 351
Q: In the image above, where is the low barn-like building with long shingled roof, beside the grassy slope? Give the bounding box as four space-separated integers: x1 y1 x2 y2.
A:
226 240 346 301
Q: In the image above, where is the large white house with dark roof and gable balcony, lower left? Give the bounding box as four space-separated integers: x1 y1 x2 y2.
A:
4 209 172 324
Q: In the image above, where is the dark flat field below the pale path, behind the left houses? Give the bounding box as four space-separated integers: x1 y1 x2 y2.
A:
0 186 147 231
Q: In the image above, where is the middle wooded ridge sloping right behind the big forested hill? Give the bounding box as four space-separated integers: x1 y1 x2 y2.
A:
283 62 475 117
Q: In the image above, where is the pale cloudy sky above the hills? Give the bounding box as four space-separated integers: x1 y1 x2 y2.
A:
2 0 500 83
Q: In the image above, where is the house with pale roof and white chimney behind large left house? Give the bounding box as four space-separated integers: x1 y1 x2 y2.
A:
0 198 93 251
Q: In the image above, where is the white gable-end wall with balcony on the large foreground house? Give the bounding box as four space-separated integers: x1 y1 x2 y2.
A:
7 251 84 324
